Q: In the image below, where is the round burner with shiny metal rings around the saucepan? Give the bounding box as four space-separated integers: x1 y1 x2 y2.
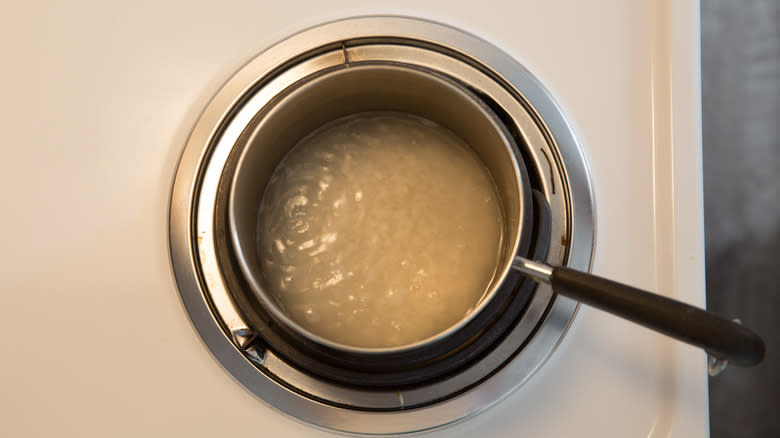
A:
170 17 594 434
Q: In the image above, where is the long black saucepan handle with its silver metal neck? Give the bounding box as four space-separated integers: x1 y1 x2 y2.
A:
512 257 765 366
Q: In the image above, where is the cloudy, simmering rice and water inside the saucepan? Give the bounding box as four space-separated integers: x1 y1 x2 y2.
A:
258 112 503 347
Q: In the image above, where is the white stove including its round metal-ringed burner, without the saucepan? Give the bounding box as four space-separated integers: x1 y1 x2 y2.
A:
0 1 708 437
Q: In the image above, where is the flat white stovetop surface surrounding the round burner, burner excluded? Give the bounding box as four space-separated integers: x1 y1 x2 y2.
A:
0 0 708 438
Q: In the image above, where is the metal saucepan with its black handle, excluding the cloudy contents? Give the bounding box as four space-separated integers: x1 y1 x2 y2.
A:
227 62 764 386
